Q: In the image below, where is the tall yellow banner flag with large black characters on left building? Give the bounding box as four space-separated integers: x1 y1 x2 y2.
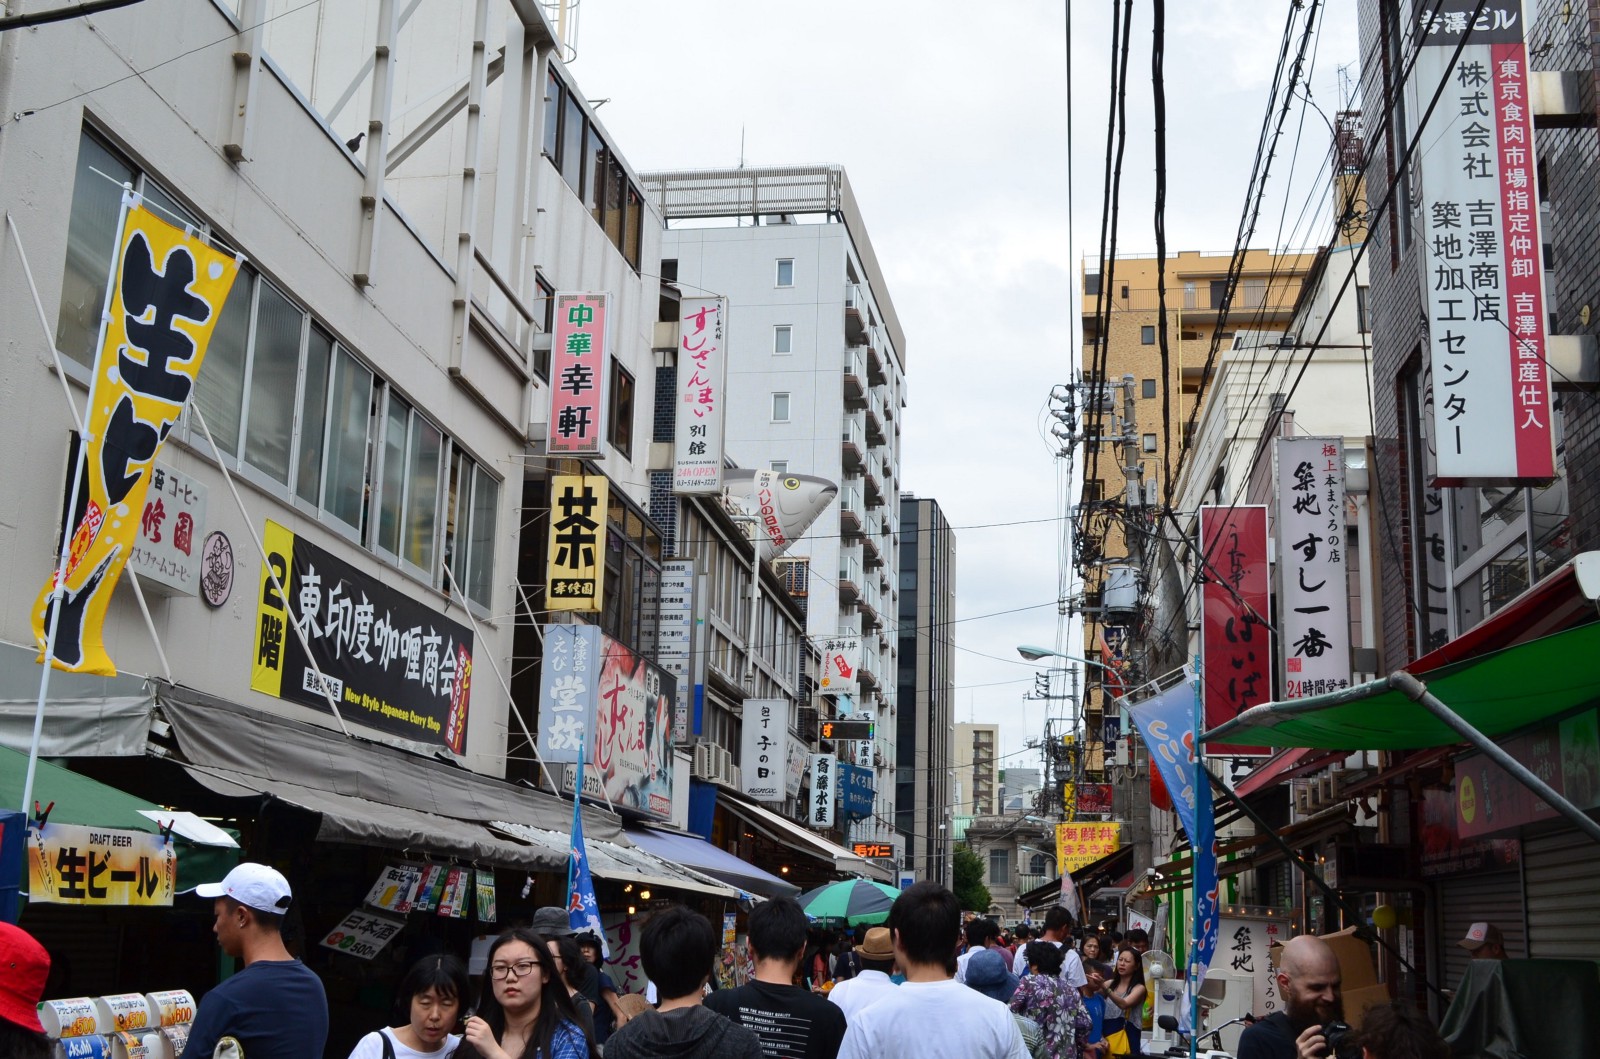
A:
32 192 238 677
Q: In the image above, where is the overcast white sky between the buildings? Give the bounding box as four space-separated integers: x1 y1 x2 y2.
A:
573 0 1357 793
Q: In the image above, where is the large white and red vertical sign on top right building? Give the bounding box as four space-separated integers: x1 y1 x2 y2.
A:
1414 0 1555 485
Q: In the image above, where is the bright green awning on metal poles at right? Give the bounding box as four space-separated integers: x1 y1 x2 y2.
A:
1202 622 1600 750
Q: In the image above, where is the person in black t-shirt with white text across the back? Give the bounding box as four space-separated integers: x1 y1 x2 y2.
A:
704 897 845 1059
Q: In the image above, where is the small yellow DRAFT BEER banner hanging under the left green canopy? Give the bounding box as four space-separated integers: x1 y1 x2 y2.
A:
27 822 178 905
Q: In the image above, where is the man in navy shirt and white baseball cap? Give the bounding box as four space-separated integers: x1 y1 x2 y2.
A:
186 861 328 1059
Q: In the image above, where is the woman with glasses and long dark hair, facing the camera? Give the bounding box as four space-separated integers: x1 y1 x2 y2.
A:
456 926 600 1059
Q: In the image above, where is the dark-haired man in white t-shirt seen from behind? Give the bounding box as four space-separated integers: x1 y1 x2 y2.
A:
838 883 1027 1059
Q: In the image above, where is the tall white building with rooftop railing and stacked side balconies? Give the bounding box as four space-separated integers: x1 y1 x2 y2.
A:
643 166 906 863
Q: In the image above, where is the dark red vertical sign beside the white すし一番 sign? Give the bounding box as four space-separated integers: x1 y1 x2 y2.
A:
1200 506 1272 757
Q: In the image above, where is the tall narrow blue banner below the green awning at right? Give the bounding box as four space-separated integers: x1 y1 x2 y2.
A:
1128 681 1218 989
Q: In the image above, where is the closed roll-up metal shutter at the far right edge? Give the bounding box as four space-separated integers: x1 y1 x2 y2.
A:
1522 829 1600 960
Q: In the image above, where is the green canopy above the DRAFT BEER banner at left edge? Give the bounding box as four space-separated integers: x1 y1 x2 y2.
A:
0 747 238 889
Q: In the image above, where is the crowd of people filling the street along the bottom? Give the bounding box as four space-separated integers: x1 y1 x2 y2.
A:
0 864 1482 1059
